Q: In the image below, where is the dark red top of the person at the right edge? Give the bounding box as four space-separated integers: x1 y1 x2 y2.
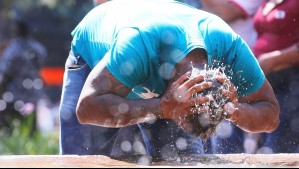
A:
253 0 299 57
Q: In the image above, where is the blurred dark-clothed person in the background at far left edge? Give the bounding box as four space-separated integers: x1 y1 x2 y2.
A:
0 20 47 135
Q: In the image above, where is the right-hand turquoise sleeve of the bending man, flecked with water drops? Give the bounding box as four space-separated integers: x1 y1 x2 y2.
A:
204 15 265 96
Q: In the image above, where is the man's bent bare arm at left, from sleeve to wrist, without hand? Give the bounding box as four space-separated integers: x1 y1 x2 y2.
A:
77 62 162 127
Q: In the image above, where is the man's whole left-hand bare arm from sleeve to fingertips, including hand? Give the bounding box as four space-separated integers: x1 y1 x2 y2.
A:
77 58 210 127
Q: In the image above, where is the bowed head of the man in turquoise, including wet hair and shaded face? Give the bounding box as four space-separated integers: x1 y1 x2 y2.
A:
172 49 228 140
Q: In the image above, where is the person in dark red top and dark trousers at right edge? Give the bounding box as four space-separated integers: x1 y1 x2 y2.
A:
253 0 299 153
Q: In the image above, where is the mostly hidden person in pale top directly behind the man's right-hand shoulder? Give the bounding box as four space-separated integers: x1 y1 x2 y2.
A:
201 0 262 154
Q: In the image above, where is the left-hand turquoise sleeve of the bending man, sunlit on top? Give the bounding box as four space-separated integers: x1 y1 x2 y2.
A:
104 28 149 88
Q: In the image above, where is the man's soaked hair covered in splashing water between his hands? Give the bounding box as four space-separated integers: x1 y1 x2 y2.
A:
187 66 229 141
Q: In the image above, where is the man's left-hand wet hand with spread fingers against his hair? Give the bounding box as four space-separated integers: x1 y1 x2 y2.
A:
160 72 212 132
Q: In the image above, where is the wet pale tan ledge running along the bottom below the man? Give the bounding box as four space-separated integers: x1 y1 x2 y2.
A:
0 154 299 168
